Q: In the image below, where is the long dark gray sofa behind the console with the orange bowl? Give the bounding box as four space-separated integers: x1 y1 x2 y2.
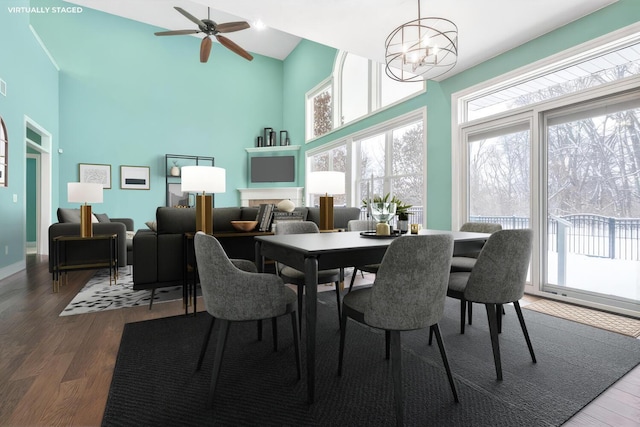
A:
133 207 360 290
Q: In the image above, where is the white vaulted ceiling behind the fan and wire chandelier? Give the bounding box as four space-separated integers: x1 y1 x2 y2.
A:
69 0 617 77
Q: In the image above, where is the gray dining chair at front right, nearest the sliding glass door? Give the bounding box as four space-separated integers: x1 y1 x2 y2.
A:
447 229 536 380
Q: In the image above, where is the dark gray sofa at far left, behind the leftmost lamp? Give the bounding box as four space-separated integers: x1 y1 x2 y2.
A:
49 208 134 272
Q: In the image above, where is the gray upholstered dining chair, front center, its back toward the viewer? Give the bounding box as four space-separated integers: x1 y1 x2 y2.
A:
338 234 458 425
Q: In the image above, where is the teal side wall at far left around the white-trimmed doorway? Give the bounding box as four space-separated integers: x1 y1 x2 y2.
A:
0 0 58 272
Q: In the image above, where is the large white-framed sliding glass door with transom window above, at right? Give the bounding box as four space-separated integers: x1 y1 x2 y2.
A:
452 25 640 315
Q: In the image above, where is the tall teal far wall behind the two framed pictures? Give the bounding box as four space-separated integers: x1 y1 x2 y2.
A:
34 2 283 228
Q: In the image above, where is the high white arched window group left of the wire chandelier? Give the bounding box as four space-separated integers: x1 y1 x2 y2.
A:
306 52 426 140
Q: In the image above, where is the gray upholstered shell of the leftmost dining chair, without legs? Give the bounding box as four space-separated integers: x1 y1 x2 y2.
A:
194 232 287 321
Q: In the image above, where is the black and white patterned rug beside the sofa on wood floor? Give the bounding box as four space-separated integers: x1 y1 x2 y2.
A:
60 267 182 316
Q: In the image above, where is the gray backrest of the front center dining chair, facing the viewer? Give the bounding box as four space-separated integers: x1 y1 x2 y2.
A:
364 234 453 330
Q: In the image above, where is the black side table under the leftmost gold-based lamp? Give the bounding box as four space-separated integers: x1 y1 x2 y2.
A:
51 234 118 292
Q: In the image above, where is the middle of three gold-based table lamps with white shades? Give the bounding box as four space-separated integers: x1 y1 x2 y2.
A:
181 166 226 234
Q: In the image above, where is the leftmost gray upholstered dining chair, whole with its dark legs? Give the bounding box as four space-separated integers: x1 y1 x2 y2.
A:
194 232 301 404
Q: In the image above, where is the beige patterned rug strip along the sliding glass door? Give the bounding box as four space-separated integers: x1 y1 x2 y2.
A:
522 299 640 338
